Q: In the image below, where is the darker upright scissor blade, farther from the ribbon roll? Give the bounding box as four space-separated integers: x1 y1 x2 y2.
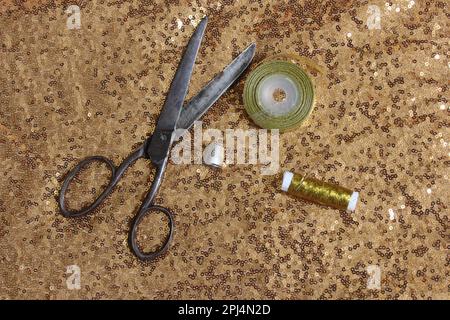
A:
155 17 208 132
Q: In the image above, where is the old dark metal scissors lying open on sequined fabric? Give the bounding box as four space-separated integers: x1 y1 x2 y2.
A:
59 17 255 261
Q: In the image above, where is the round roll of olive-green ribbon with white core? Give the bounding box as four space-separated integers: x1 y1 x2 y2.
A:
244 55 316 132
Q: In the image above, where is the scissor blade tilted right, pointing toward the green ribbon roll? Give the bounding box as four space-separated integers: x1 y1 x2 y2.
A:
177 43 256 130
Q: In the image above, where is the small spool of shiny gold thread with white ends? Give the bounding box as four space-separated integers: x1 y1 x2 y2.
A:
281 171 359 212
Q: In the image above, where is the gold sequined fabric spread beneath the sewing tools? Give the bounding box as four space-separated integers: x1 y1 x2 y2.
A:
0 0 450 299
